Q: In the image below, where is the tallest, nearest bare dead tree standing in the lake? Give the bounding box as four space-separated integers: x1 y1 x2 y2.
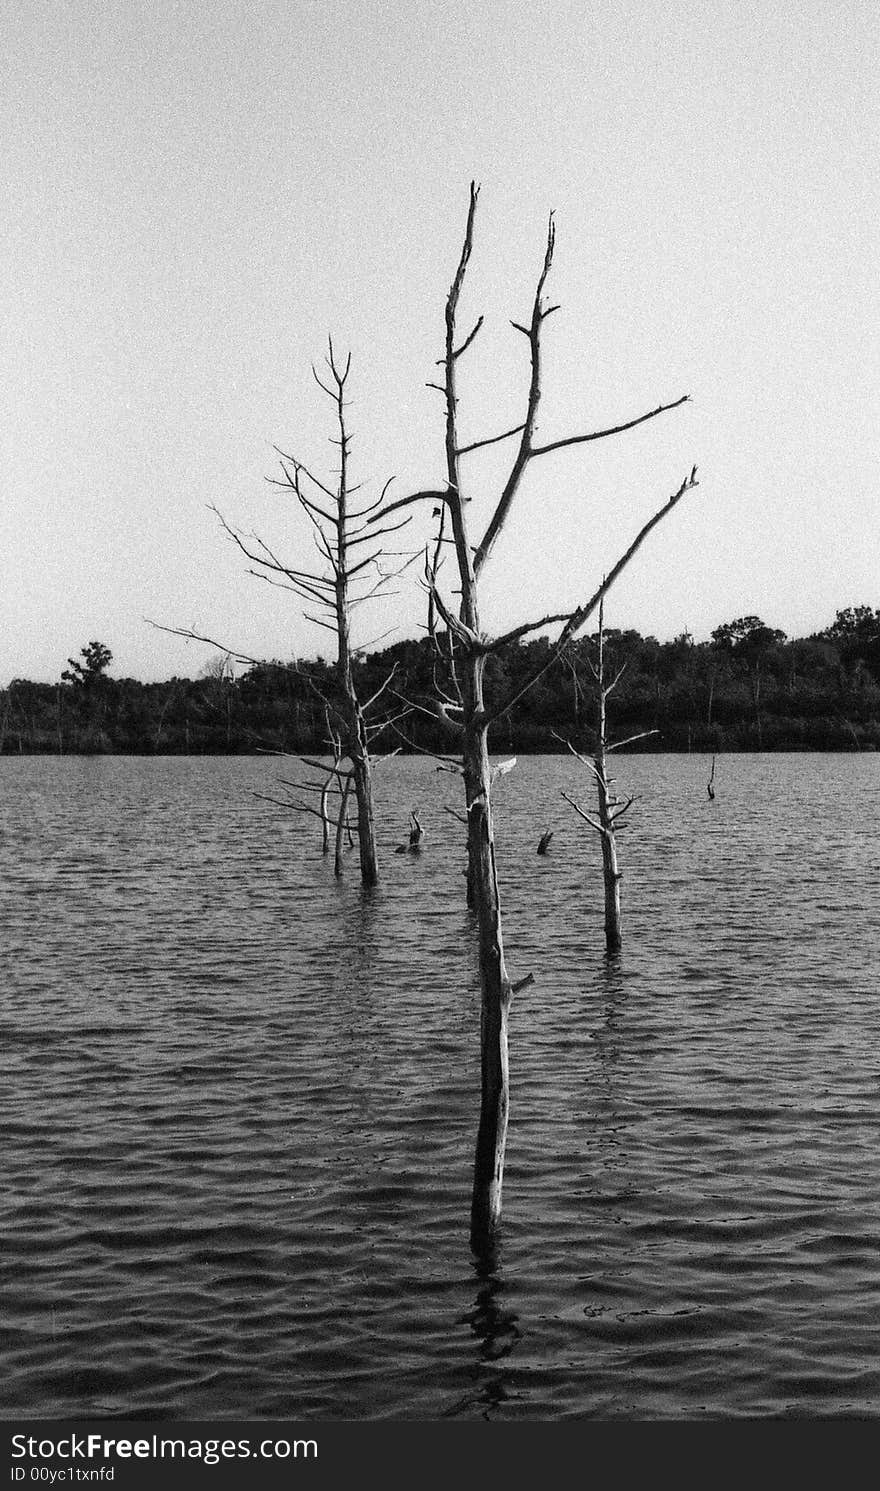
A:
368 183 697 1251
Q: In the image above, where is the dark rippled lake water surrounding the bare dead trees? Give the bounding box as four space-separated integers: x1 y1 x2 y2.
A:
0 754 880 1419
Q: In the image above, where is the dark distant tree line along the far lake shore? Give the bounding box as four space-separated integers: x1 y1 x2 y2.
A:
0 605 880 754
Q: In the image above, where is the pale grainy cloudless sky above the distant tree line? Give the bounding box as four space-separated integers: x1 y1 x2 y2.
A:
0 0 880 684
